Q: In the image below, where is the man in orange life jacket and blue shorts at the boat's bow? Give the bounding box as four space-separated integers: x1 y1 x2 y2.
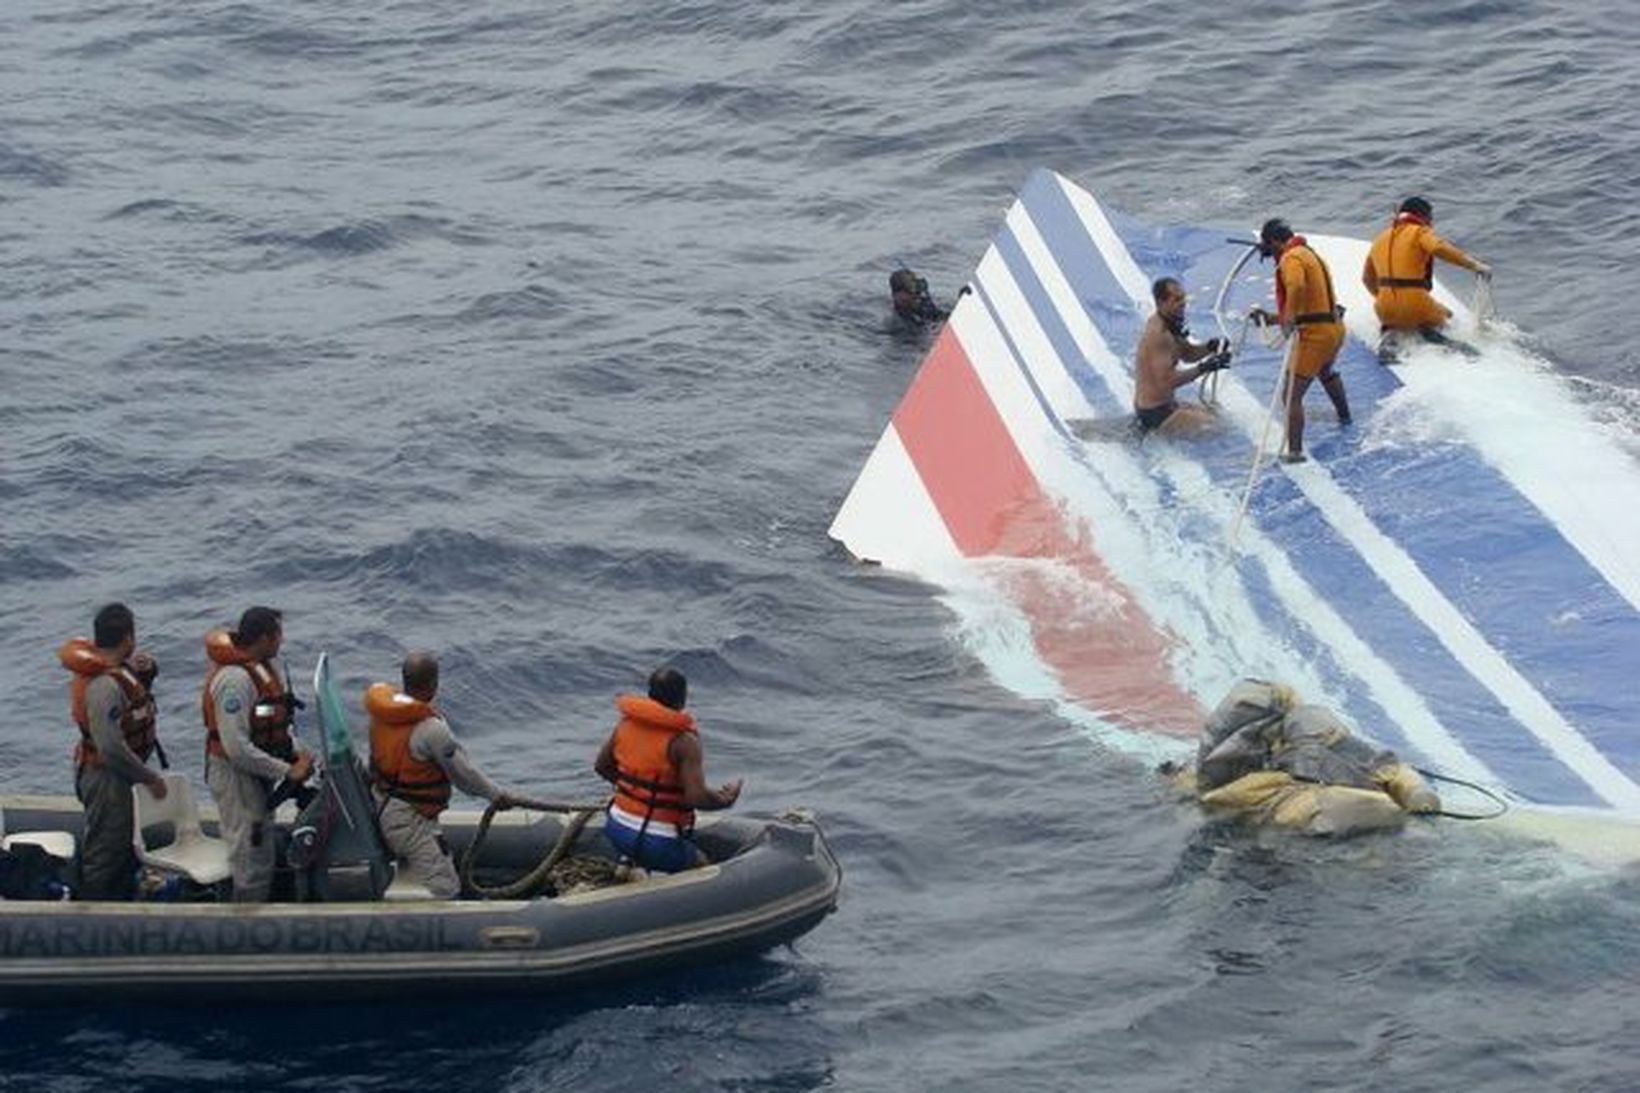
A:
592 668 741 873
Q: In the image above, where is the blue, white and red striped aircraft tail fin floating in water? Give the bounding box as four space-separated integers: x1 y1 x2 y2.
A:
831 171 1640 832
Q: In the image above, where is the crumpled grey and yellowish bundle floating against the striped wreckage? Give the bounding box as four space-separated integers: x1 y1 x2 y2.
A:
1163 679 1440 835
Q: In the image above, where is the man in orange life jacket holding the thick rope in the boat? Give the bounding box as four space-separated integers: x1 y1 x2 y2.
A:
364 653 518 899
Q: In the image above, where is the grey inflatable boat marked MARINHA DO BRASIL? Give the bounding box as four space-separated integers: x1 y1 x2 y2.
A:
0 658 841 1006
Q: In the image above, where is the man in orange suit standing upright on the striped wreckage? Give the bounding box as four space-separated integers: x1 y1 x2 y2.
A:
1253 218 1351 463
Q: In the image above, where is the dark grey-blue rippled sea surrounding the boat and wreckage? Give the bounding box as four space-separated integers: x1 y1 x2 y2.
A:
0 0 1640 1093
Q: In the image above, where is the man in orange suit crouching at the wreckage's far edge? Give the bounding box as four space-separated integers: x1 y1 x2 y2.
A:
1361 197 1492 358
